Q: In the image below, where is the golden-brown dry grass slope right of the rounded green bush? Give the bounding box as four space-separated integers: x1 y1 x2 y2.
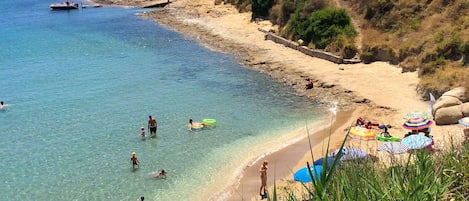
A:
349 0 469 95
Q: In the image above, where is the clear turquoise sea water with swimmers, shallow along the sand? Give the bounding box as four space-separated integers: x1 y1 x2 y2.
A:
0 0 324 201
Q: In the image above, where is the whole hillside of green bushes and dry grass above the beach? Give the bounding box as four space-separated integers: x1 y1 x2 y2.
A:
220 0 469 97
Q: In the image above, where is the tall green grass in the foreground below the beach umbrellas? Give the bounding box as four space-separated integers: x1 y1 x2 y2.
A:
268 131 469 201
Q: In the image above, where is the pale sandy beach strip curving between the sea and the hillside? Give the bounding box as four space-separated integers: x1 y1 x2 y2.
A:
89 0 461 200
